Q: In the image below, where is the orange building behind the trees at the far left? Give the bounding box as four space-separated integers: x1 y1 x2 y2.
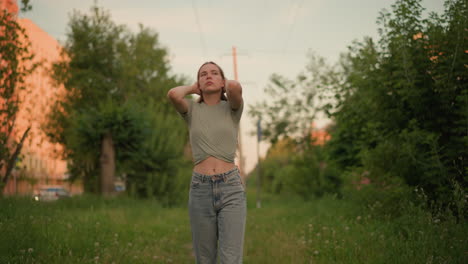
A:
0 0 80 195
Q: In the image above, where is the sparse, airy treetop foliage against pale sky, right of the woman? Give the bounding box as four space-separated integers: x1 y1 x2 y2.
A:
249 54 330 144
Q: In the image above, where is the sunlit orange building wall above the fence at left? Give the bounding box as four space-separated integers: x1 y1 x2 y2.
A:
17 19 66 180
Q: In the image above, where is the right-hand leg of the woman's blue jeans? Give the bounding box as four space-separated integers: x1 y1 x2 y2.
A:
218 174 247 264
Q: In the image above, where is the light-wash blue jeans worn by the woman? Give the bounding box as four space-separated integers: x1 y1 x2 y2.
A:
189 168 247 264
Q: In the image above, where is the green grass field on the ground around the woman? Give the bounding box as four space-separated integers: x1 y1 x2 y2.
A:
0 191 468 263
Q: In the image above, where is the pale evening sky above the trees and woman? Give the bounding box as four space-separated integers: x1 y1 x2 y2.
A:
18 0 443 172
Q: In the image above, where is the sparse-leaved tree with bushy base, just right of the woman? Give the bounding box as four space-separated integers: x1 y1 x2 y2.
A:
249 53 341 199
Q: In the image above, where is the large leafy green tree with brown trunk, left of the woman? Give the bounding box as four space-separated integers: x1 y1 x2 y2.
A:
45 6 190 199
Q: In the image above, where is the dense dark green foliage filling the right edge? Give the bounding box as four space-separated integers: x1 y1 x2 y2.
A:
327 0 468 210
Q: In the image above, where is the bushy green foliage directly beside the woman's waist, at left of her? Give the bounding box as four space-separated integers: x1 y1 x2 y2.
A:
123 101 192 205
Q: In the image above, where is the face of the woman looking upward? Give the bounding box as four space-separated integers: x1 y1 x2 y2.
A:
198 63 224 93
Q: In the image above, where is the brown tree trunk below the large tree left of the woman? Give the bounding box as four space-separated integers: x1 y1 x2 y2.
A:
100 133 115 196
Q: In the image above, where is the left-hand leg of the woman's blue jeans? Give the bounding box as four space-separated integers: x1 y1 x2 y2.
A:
189 176 218 264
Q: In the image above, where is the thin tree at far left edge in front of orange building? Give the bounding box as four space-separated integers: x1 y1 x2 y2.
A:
0 0 37 193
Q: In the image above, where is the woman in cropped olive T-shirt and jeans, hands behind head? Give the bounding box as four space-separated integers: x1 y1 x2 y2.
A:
167 62 246 263
